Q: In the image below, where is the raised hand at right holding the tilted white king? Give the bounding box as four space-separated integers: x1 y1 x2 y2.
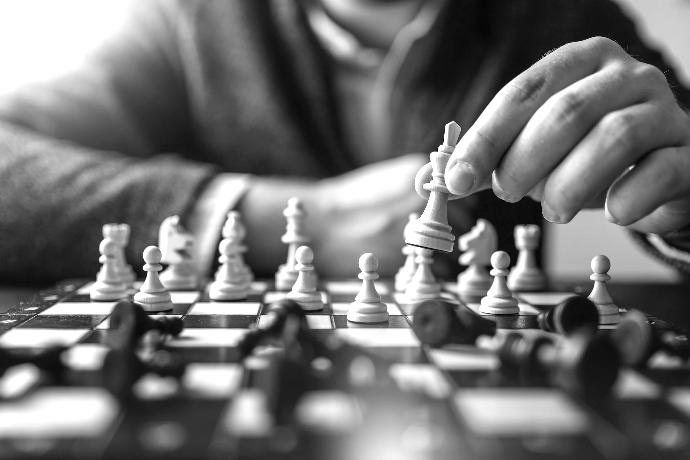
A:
438 37 690 234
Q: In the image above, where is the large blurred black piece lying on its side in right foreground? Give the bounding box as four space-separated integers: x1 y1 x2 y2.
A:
497 331 620 398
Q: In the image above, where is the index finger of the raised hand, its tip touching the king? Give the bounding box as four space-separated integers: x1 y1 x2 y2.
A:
446 38 630 195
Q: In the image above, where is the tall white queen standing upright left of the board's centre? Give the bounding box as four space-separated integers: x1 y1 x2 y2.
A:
275 197 309 291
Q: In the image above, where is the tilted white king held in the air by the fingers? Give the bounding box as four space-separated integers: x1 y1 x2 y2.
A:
405 121 460 252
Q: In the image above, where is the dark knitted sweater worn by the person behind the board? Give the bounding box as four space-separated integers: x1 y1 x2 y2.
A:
0 0 690 282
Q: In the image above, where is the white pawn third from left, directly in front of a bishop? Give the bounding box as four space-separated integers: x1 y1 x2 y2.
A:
208 238 250 301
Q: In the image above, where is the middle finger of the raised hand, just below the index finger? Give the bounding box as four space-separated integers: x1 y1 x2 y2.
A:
492 61 664 203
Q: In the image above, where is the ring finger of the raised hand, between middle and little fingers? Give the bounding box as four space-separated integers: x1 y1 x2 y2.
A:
542 103 685 223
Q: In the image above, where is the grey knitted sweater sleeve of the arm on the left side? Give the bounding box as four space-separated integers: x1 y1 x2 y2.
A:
0 1 222 283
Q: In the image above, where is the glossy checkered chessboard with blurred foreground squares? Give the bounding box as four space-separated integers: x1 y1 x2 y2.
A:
0 280 690 460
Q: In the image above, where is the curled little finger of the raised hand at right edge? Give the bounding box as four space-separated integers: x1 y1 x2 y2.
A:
606 147 690 234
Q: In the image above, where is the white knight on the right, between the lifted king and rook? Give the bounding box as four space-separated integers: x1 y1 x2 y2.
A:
457 219 498 303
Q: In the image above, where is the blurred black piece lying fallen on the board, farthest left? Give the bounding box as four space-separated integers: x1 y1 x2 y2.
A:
108 300 184 348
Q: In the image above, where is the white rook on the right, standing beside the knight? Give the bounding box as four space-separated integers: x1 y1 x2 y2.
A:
508 225 546 292
